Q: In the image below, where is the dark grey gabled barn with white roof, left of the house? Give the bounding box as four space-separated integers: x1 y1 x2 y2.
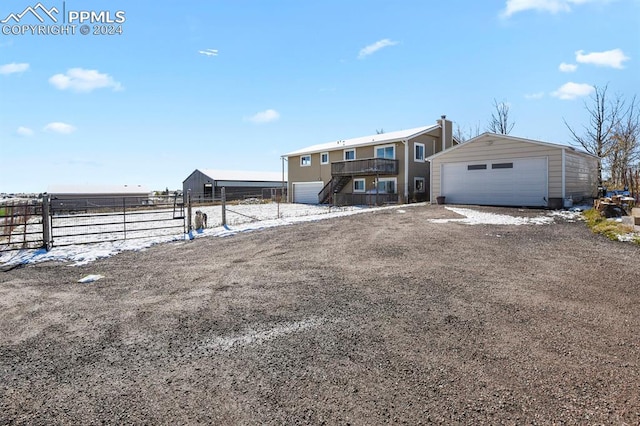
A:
182 169 287 202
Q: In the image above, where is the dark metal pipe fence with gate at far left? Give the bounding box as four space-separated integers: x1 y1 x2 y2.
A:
0 195 187 252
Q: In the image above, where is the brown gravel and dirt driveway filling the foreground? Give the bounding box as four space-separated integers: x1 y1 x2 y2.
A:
0 205 640 425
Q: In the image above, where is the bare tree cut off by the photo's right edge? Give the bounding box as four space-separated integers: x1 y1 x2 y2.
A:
606 96 640 187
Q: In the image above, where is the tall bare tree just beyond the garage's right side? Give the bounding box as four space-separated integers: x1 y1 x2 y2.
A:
563 85 624 185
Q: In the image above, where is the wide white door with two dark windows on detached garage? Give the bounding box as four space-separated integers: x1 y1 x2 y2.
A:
441 157 547 207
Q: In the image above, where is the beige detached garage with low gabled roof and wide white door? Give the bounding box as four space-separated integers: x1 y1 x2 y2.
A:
428 133 598 208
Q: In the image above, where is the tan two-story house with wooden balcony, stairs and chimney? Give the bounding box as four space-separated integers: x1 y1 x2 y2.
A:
283 116 457 205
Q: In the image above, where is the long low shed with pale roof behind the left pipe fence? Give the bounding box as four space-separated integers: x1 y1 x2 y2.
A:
47 185 151 211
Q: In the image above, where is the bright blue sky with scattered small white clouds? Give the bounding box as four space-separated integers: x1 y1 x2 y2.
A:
0 0 640 193
